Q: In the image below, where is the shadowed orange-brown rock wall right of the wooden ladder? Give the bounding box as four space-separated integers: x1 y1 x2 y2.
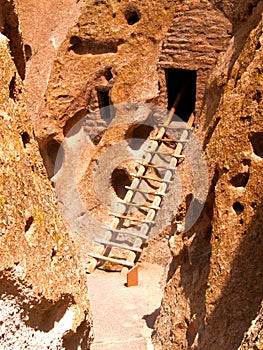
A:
155 2 263 350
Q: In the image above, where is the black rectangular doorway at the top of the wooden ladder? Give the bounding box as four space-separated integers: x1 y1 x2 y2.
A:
165 68 196 122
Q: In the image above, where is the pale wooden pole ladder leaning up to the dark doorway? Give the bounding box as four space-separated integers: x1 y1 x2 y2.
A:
86 91 194 273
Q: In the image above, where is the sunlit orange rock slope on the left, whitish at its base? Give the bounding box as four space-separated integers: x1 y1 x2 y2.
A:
0 13 91 350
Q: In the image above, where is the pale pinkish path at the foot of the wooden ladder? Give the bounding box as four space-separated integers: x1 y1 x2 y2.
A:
88 263 164 350
